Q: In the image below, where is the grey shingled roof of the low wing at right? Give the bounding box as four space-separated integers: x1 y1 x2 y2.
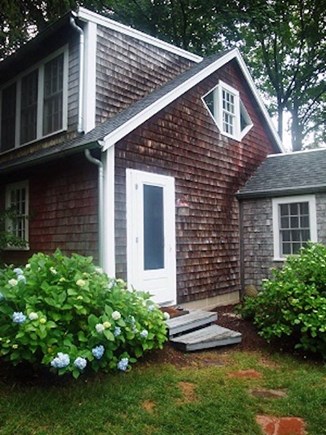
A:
237 148 326 199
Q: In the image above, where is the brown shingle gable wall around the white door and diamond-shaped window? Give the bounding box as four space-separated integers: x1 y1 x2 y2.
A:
116 62 272 303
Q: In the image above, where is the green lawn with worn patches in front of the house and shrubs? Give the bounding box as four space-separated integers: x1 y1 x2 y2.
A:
0 350 326 435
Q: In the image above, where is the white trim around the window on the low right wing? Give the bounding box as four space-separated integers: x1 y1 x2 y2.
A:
273 195 317 261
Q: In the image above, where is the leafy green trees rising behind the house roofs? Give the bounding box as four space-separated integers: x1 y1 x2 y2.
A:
0 0 326 150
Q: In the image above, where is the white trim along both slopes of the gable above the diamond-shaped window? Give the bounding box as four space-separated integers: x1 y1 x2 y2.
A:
102 48 284 152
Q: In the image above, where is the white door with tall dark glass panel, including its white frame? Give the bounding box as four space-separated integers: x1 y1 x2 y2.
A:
127 169 176 305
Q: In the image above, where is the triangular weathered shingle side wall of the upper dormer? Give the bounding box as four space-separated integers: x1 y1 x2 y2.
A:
96 26 194 125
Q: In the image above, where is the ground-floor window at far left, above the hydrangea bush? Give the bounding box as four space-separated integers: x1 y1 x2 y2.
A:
6 181 29 248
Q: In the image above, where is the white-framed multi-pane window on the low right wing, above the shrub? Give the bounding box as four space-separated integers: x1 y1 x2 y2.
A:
273 195 317 259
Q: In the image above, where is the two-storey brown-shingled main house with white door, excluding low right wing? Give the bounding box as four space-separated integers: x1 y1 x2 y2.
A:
0 8 282 307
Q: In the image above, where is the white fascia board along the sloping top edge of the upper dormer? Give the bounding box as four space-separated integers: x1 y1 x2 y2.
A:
77 7 203 63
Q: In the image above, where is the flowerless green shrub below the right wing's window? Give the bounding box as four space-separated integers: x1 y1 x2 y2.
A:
239 243 326 358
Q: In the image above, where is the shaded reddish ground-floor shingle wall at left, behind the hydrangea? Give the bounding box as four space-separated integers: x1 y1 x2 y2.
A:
0 155 98 264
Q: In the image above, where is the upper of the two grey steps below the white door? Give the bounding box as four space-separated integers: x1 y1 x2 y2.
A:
166 310 217 337
